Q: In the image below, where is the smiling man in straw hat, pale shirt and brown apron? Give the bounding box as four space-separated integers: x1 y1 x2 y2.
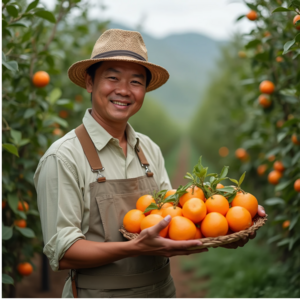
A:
34 29 266 298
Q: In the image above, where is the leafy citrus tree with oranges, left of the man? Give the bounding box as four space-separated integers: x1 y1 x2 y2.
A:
2 0 106 297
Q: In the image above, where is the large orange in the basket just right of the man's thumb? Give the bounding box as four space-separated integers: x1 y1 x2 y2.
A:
169 216 197 241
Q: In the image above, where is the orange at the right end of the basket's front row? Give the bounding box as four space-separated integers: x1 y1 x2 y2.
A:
226 206 252 232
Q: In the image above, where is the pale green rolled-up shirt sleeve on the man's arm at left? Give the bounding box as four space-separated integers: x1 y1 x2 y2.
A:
34 155 85 271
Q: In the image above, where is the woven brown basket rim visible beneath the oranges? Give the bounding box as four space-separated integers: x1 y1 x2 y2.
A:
119 215 268 250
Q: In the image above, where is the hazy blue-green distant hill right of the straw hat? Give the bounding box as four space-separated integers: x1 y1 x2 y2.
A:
109 22 226 121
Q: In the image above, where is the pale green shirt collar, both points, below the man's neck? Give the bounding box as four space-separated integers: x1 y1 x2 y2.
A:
82 109 139 151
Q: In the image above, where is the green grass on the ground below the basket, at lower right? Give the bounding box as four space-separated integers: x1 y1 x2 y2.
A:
181 232 300 298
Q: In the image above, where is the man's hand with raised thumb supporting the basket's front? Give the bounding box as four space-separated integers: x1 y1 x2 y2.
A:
131 216 208 257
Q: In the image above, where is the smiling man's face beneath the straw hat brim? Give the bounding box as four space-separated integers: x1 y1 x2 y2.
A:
86 61 146 123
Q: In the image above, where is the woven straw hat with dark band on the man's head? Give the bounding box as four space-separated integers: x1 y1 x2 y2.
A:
68 29 169 92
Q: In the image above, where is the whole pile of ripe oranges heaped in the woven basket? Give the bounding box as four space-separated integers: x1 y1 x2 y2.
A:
123 188 258 240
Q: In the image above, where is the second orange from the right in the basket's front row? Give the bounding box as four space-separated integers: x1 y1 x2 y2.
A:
201 212 228 237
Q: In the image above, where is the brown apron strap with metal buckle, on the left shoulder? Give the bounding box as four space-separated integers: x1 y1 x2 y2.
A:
75 124 106 182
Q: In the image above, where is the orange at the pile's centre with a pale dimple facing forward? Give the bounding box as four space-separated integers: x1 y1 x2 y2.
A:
182 198 207 223
